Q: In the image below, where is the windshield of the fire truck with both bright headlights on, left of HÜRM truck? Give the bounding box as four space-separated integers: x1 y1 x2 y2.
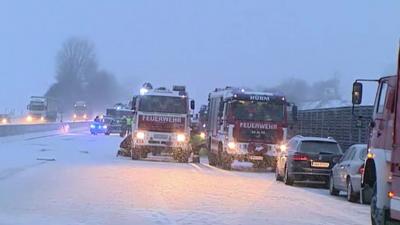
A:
139 96 187 114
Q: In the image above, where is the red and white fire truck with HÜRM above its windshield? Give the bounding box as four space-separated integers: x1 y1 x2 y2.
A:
207 87 288 170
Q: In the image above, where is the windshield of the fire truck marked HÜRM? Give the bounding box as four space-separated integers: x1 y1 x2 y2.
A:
232 101 285 122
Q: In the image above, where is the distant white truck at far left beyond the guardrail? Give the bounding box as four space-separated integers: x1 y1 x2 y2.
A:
26 96 59 122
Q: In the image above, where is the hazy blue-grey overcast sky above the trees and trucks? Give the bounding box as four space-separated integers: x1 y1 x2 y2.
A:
0 0 400 111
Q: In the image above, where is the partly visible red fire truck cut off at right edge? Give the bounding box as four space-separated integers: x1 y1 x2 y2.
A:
353 46 400 225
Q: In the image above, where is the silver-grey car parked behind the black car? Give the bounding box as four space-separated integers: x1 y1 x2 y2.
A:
329 144 368 202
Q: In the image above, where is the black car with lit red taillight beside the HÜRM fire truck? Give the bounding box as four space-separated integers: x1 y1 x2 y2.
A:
275 135 343 187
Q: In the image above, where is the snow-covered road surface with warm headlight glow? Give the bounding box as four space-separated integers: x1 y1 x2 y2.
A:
0 131 370 225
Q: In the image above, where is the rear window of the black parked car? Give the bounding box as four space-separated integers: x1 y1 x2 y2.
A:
300 141 341 154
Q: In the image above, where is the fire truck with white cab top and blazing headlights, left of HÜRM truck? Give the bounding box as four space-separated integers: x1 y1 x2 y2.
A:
131 83 194 162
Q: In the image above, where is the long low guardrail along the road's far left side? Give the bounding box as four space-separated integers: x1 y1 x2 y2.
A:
0 121 89 137
